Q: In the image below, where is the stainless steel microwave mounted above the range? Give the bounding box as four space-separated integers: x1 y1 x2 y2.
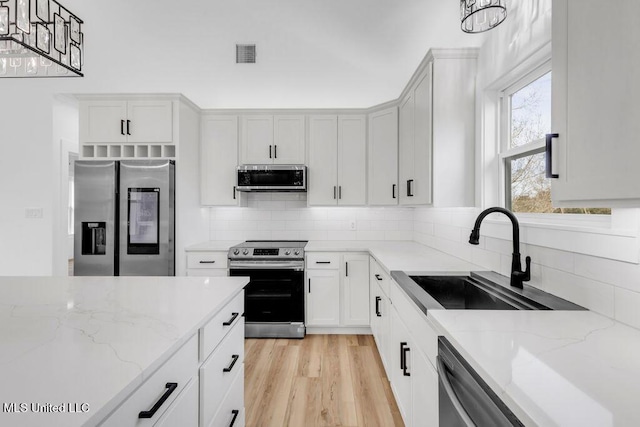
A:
236 165 307 191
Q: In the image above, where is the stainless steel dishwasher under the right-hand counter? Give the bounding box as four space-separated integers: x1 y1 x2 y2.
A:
437 337 523 427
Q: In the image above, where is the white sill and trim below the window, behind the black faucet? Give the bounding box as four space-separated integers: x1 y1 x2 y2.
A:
481 214 640 264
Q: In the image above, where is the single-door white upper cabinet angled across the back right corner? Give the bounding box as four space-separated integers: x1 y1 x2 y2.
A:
368 107 398 205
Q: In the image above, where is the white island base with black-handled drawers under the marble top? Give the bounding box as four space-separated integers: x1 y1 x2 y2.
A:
98 292 244 427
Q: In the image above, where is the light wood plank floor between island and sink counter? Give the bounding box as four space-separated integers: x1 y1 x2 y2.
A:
245 335 404 427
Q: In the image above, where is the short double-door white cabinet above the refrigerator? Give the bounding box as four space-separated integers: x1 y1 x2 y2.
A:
80 100 173 143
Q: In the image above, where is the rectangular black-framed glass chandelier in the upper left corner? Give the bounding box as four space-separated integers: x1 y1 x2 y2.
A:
0 0 84 77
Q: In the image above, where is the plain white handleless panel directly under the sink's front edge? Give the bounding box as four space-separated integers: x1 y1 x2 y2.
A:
391 282 438 367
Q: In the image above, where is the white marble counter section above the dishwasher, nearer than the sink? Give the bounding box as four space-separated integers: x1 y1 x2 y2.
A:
428 310 640 427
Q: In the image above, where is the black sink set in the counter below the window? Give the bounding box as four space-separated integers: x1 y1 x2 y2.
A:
391 271 585 313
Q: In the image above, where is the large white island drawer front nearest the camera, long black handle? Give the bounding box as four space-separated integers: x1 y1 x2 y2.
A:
100 335 198 427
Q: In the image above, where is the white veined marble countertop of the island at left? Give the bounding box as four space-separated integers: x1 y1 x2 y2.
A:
0 277 248 427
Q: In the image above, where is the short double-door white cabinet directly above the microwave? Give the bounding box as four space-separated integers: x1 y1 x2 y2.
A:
240 115 305 164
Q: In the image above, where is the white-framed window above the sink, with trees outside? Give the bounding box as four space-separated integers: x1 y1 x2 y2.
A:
500 65 611 214
